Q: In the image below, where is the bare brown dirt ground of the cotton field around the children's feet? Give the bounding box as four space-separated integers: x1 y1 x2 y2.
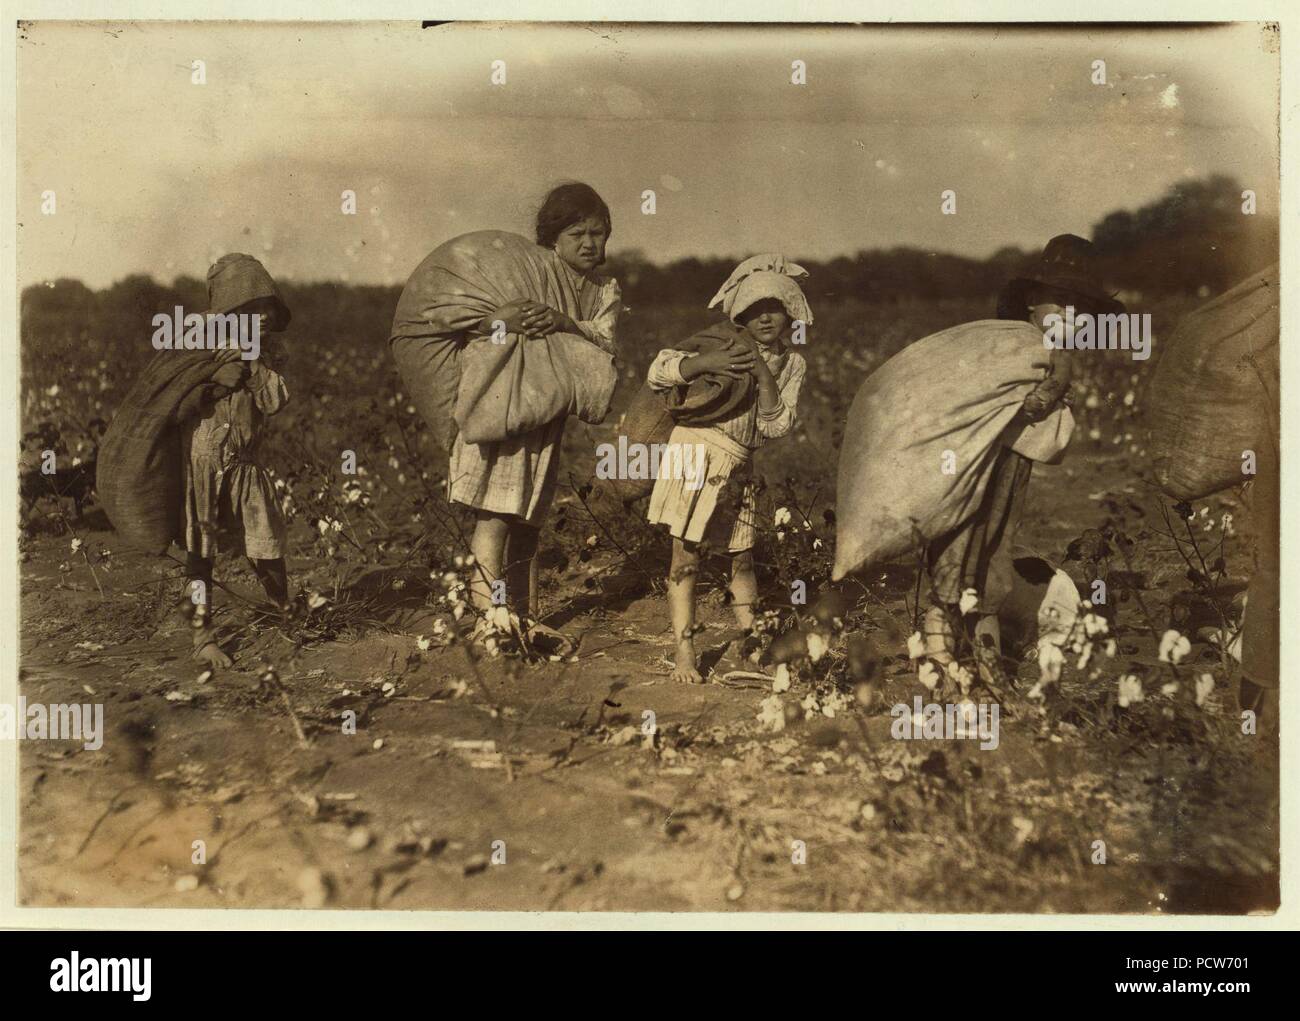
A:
20 299 1278 913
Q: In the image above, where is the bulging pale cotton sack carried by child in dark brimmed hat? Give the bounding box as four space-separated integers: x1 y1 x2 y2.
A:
832 320 1074 580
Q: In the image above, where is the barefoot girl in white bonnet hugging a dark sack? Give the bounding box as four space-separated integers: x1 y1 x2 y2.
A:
646 255 813 684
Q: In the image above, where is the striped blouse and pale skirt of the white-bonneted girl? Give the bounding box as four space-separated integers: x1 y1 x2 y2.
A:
646 346 807 553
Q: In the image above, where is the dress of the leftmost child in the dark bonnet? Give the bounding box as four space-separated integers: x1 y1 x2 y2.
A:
182 359 289 561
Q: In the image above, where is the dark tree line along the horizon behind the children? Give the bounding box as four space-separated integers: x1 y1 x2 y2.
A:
21 176 1278 322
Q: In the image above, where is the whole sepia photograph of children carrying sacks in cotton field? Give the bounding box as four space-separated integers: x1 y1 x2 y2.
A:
0 12 1294 926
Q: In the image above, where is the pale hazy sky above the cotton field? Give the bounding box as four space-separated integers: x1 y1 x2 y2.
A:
18 22 1278 287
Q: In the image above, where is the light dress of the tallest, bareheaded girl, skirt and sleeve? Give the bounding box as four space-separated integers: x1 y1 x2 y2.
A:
447 270 623 525
